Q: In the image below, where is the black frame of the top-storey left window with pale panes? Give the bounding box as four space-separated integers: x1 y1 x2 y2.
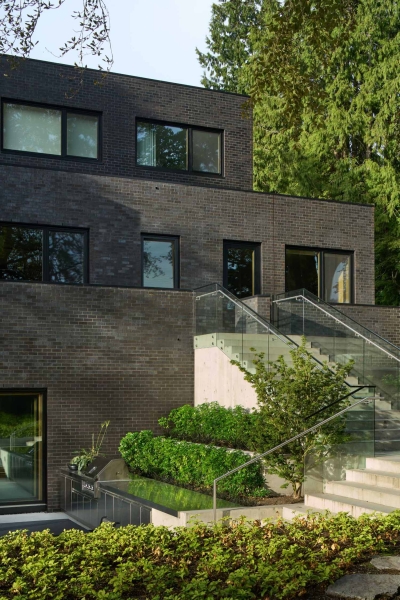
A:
0 98 103 163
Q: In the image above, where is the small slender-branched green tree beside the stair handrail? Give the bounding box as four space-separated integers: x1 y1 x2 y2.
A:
232 338 353 498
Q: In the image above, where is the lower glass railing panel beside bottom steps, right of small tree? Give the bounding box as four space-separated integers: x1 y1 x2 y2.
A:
304 399 377 492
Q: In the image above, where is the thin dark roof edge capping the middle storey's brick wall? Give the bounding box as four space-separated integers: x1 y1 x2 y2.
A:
0 155 375 208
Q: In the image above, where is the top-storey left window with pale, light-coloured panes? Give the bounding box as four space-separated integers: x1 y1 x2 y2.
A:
2 101 100 159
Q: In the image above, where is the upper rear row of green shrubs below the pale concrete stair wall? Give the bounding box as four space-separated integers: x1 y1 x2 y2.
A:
158 402 258 450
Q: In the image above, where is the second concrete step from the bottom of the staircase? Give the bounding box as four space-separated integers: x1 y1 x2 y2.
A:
324 481 400 508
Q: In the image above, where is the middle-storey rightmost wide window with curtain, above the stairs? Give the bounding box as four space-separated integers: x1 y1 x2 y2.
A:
285 248 352 303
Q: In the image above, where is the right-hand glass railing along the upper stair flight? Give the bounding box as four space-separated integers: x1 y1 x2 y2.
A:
273 290 400 418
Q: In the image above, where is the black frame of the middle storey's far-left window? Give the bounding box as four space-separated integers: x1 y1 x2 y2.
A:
0 221 89 285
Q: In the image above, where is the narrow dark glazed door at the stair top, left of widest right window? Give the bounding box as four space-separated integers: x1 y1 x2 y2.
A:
224 241 261 298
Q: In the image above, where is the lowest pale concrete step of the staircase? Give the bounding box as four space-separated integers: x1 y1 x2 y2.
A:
304 493 396 518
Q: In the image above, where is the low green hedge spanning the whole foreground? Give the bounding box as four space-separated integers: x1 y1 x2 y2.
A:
0 511 400 600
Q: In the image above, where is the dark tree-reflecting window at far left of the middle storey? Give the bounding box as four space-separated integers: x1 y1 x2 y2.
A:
0 224 88 284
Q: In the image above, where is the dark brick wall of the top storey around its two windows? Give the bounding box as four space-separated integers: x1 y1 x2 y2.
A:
0 57 253 189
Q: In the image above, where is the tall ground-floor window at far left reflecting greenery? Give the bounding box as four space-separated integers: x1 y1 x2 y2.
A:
0 391 44 505
